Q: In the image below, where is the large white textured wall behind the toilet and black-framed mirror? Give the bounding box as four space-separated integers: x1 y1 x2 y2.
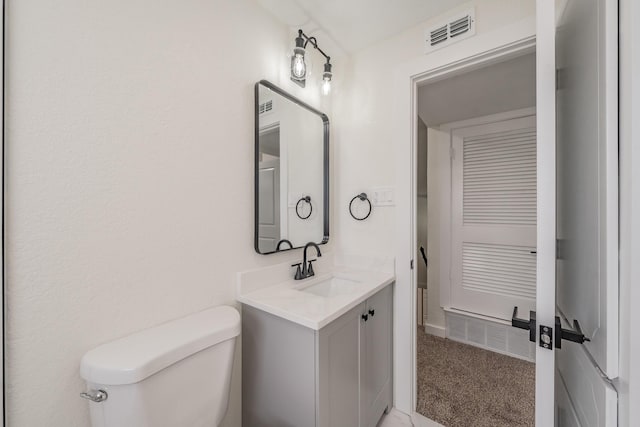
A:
5 0 327 427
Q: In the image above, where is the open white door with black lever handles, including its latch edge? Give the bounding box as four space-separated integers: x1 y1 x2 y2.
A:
536 0 618 427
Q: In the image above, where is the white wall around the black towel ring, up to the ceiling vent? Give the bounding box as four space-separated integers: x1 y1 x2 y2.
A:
332 0 535 255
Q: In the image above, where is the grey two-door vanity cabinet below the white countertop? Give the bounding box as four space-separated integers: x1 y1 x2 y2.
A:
242 285 393 427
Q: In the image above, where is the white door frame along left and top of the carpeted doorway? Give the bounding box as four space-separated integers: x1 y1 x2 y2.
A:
393 12 536 426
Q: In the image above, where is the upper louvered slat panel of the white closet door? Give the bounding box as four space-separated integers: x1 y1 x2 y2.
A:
463 128 536 226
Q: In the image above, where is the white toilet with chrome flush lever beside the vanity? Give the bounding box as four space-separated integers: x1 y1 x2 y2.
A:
80 306 240 427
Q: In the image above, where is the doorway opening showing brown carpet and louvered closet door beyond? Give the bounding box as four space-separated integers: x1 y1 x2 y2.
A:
413 51 537 426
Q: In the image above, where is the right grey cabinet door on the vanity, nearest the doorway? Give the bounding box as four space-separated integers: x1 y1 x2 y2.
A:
362 286 393 427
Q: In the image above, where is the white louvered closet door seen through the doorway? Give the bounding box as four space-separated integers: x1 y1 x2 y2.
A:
450 116 536 320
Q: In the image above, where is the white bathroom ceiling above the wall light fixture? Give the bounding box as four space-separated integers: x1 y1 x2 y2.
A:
257 0 469 56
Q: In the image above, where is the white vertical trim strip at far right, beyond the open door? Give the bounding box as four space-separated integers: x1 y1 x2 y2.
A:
615 0 640 426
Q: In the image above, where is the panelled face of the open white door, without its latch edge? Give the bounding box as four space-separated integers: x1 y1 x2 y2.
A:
556 0 618 426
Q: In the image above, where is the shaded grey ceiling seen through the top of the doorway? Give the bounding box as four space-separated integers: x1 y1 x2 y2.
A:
418 53 536 126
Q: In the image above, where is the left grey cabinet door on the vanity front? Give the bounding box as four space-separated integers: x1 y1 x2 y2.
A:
317 303 365 427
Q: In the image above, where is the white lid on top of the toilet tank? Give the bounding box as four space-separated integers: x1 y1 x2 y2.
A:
80 306 240 385
